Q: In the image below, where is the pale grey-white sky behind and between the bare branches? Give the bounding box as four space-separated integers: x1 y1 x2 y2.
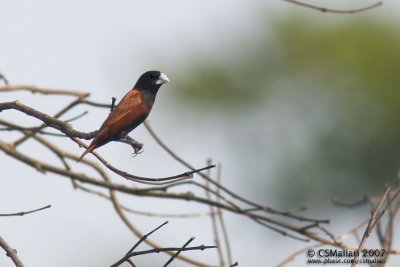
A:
0 0 400 267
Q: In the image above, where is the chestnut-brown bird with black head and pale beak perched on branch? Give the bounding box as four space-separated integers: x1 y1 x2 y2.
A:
78 71 169 162
